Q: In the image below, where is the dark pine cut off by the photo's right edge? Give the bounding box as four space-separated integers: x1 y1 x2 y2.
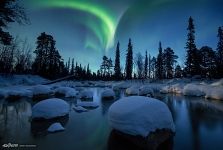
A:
216 27 223 78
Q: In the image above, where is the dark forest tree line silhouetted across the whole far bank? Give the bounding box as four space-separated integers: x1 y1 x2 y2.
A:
0 0 223 80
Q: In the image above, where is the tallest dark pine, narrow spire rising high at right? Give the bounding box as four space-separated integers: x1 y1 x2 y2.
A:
185 17 200 76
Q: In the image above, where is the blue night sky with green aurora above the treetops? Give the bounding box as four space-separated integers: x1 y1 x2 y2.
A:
9 0 223 71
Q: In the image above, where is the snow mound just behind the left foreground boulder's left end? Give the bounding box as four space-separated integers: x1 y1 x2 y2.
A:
30 85 52 95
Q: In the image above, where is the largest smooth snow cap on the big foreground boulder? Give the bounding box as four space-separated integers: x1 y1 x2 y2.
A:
108 96 175 137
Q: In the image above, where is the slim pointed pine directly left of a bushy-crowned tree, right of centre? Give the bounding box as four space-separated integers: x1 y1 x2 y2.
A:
156 42 163 79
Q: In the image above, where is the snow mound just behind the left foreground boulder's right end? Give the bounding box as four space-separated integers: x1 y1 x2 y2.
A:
54 87 78 97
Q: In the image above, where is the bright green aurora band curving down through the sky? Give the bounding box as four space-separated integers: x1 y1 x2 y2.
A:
33 0 123 52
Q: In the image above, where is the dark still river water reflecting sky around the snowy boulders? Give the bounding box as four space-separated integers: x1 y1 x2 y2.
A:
0 88 223 150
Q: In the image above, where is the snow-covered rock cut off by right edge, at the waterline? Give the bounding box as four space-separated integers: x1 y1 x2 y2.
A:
205 87 223 100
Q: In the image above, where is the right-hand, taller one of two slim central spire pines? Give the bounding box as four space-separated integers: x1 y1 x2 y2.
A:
125 39 133 80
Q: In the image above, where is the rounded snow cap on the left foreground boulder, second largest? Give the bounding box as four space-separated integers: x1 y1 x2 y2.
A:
32 98 69 119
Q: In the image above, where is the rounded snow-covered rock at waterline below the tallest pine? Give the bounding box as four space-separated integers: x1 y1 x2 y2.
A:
183 84 205 96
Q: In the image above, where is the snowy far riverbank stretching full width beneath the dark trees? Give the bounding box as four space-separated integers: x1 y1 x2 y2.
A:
0 75 223 100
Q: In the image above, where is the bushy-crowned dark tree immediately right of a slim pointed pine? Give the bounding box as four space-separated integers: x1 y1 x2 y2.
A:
163 47 178 79
